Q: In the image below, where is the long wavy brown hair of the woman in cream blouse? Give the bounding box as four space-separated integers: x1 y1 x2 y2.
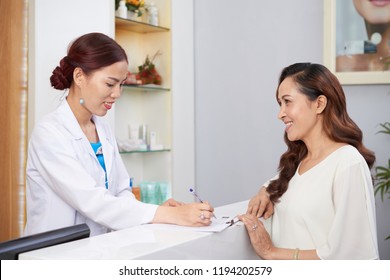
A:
267 63 375 203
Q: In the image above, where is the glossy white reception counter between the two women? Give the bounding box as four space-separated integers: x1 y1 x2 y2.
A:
19 201 259 260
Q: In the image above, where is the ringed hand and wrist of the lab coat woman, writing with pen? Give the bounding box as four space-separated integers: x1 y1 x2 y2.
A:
152 202 214 227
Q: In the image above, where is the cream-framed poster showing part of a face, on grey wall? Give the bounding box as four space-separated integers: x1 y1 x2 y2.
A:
324 0 390 84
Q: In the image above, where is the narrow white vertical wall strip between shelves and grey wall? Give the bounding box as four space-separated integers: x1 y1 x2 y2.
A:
171 0 195 201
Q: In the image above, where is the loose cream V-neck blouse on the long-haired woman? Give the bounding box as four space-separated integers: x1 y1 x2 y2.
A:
266 145 379 259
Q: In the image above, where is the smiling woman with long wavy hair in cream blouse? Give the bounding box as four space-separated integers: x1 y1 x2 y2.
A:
240 63 379 259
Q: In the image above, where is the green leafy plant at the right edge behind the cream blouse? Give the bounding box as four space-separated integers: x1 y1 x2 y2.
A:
374 122 390 240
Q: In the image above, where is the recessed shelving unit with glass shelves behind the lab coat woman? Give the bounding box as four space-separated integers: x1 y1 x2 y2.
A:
113 0 174 186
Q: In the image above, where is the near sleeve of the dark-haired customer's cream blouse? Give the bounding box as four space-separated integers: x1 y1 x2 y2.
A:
317 159 379 260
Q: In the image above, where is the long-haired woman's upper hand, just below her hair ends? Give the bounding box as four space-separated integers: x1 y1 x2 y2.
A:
246 187 274 219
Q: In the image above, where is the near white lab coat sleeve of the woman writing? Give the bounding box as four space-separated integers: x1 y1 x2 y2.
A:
29 122 158 230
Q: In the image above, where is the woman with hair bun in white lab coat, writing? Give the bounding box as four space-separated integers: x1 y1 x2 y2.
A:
25 33 213 235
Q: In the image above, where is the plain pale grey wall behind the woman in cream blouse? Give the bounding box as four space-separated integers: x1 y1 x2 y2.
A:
194 0 390 259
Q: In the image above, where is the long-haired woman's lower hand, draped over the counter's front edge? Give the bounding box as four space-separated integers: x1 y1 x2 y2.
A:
238 214 274 259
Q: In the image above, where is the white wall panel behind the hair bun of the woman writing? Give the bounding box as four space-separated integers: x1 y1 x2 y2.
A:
28 0 114 135
